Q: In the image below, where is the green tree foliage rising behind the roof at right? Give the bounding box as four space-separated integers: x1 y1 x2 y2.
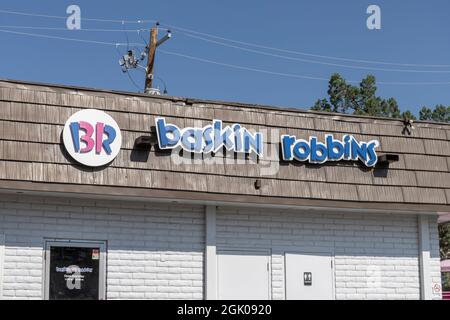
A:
311 73 450 122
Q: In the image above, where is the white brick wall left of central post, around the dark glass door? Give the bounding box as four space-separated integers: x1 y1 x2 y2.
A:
0 195 205 299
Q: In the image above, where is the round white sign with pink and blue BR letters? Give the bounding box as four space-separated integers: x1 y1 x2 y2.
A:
63 109 122 167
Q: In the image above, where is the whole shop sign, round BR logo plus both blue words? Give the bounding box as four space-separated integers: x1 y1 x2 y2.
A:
63 109 380 167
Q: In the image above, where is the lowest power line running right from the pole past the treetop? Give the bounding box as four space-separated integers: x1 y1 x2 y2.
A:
159 50 450 85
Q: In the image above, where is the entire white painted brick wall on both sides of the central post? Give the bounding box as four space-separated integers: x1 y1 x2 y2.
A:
0 195 440 299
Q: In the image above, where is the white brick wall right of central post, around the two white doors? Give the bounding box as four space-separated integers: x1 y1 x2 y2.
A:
217 208 440 299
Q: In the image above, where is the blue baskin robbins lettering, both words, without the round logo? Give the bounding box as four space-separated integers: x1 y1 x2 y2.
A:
155 117 380 167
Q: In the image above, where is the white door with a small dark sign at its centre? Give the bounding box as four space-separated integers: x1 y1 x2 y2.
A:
285 253 334 300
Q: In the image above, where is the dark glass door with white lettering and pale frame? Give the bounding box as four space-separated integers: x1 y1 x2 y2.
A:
45 241 105 300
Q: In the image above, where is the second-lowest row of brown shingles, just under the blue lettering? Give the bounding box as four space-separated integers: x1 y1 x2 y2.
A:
0 140 442 188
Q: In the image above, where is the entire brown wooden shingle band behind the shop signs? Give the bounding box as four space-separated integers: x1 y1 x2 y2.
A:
0 81 450 205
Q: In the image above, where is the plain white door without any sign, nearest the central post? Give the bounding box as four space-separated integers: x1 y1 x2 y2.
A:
217 252 270 300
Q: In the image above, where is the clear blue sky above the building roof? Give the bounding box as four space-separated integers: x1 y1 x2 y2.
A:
0 0 450 113
